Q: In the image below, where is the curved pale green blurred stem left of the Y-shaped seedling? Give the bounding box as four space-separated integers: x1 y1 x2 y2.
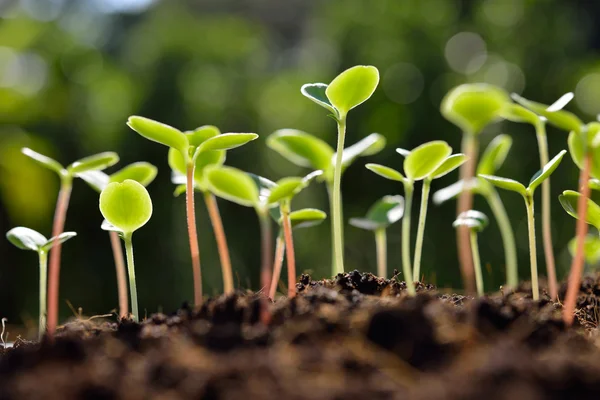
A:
484 185 519 288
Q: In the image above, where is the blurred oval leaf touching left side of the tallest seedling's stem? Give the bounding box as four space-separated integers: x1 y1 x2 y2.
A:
267 129 334 170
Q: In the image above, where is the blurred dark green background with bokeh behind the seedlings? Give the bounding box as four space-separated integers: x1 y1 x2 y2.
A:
0 0 600 323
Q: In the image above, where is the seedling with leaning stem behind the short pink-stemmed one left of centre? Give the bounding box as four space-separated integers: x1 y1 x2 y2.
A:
269 208 327 299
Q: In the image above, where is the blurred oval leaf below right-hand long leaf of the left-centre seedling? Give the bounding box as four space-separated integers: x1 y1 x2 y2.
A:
205 166 260 208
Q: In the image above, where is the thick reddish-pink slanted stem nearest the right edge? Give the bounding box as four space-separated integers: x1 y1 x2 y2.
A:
563 152 592 325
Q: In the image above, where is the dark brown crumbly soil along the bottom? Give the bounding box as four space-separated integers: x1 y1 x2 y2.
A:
0 271 600 400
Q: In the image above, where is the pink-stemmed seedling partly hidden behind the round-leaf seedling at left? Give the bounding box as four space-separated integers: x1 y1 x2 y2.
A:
77 162 158 318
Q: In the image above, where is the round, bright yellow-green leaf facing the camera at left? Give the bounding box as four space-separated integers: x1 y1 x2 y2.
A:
100 179 152 233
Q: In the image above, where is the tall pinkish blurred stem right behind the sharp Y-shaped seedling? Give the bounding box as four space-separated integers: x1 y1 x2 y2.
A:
536 121 558 300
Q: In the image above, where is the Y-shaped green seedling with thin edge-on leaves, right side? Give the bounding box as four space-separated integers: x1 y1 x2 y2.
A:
479 150 567 300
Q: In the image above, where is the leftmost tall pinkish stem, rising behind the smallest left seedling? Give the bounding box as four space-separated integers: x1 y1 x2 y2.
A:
47 175 73 338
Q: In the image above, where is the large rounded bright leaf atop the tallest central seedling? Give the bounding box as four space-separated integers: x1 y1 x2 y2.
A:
325 65 379 117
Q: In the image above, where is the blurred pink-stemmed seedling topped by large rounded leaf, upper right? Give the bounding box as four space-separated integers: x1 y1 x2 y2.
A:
441 83 510 291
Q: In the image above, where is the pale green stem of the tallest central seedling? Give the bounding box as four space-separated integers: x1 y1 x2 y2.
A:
331 116 346 276
